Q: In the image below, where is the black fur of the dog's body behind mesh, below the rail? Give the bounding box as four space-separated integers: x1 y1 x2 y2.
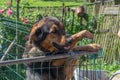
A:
27 59 65 80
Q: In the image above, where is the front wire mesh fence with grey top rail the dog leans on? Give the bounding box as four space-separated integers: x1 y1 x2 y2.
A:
0 52 104 80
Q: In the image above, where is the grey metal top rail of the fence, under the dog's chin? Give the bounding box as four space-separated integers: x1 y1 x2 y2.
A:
0 51 98 67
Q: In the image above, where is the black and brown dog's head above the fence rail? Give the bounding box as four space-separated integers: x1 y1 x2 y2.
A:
29 17 67 52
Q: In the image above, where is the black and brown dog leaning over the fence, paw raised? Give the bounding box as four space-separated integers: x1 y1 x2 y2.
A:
23 17 100 80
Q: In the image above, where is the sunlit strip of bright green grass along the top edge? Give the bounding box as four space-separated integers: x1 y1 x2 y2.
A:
0 0 83 9
